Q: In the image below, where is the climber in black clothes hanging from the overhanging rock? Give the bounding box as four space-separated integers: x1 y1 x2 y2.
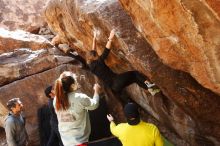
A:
87 30 160 95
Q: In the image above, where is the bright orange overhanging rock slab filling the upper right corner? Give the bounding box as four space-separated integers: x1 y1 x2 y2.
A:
120 0 220 94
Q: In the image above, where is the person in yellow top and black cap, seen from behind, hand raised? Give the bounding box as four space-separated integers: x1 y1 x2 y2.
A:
107 103 164 146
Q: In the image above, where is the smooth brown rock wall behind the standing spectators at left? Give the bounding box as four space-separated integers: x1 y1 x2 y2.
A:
0 65 103 146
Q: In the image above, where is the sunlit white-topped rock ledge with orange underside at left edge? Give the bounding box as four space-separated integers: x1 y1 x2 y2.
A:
0 28 52 53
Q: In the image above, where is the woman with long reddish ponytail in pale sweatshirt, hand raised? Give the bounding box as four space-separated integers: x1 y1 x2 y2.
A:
54 72 100 146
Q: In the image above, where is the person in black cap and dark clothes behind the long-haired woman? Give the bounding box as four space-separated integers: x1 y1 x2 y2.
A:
44 86 63 146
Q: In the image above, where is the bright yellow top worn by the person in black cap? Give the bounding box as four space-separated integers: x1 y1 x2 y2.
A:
111 121 162 146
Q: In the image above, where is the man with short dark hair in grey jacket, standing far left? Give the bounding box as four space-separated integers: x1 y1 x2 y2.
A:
5 98 28 146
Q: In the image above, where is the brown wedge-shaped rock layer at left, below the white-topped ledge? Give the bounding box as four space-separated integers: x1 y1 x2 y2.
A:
0 48 73 86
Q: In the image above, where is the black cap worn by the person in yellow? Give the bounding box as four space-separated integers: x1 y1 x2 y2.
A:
124 102 140 125
